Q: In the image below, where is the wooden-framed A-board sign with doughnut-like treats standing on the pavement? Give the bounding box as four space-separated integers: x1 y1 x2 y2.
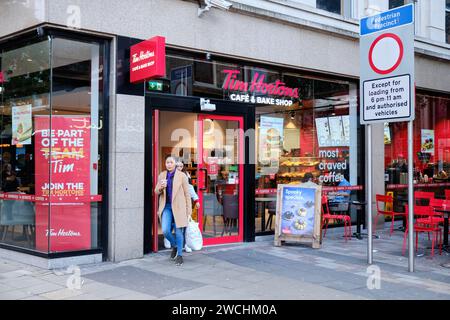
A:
274 183 322 249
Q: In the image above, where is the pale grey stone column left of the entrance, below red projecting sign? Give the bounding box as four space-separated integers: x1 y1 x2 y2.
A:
108 95 145 261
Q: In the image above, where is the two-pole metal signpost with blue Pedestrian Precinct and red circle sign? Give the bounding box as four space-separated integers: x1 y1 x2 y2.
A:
360 4 415 272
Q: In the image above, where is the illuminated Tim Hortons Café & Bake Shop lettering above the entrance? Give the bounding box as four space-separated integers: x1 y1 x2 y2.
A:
223 70 298 106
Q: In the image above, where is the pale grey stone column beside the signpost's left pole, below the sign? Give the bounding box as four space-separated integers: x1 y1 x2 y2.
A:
366 123 385 230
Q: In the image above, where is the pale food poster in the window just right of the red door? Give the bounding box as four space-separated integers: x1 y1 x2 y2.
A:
259 116 283 174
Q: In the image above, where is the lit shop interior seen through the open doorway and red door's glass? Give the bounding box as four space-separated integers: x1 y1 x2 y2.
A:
158 111 240 245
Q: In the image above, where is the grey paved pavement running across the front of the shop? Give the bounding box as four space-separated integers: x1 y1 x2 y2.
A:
0 225 450 300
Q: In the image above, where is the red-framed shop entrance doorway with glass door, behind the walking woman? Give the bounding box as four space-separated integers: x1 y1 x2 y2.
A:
152 110 243 251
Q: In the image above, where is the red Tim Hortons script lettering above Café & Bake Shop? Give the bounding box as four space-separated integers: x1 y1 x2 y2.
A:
223 70 298 98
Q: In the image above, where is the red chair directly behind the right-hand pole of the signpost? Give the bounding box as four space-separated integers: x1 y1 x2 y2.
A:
402 205 442 257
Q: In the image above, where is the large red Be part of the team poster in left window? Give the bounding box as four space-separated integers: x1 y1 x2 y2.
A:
35 116 91 252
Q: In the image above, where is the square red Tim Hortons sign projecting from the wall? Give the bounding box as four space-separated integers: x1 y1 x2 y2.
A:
130 36 166 83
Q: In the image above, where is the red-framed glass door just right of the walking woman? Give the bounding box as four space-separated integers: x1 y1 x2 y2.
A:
197 115 244 245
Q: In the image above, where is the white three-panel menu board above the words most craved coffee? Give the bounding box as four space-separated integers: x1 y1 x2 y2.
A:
315 115 350 148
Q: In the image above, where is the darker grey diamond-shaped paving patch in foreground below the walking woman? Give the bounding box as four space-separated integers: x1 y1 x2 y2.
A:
86 266 203 297
